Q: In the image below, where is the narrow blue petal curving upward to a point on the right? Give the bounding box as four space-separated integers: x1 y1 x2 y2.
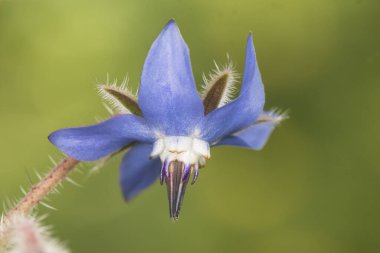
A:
200 34 265 143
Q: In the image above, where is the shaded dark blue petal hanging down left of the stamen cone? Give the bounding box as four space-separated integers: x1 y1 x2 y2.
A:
120 144 161 200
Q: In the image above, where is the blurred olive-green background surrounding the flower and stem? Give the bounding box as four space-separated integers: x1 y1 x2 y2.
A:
0 0 380 253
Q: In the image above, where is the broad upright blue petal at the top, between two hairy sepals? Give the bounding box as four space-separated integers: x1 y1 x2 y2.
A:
138 20 204 135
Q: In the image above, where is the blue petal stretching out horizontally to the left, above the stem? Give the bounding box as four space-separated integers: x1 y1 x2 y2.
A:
49 114 154 161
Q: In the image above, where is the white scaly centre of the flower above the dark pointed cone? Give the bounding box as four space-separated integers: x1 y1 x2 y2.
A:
150 136 210 167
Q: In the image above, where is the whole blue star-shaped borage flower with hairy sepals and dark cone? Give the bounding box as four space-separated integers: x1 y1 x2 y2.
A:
49 20 283 219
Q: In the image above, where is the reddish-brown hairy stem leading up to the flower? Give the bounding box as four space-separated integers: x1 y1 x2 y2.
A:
6 157 79 218
